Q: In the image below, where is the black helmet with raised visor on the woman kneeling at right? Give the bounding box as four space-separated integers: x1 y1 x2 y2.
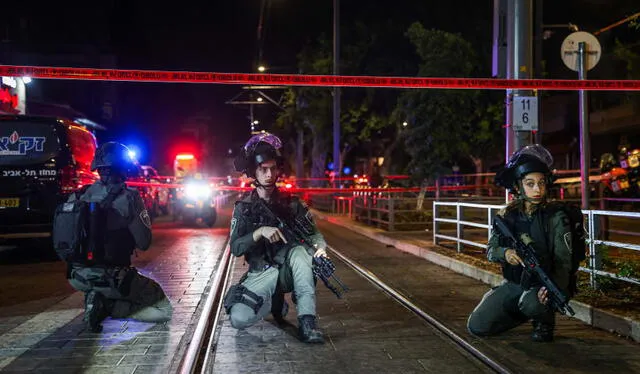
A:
495 144 553 192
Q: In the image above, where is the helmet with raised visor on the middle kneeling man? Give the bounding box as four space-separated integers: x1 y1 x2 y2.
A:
233 132 282 178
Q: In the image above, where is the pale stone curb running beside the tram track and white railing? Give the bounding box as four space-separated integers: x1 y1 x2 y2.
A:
312 209 640 342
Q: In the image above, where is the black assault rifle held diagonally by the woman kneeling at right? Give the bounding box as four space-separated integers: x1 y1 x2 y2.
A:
493 216 576 316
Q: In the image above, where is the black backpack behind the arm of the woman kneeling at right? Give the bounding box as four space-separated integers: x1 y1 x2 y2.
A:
547 201 587 297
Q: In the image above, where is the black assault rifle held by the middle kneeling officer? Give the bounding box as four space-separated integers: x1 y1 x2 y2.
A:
258 199 349 299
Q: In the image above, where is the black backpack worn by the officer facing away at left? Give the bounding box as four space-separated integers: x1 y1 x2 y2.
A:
52 190 118 266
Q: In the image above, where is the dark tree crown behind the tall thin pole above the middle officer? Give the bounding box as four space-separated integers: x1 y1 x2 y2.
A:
277 19 417 177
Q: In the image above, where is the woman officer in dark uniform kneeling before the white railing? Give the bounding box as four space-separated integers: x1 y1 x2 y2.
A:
467 145 572 342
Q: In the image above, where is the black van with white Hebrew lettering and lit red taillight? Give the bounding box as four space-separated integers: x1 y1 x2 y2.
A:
0 115 98 241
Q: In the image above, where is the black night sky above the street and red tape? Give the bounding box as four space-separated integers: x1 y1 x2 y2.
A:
0 0 639 169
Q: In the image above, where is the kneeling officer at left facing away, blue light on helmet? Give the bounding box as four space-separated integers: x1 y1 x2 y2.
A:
65 142 172 332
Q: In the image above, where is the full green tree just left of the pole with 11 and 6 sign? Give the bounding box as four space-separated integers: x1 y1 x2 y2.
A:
395 23 503 180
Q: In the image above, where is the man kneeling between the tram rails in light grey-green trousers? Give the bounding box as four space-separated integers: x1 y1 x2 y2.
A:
225 133 326 343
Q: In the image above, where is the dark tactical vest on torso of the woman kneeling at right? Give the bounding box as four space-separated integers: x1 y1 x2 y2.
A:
500 209 553 289
